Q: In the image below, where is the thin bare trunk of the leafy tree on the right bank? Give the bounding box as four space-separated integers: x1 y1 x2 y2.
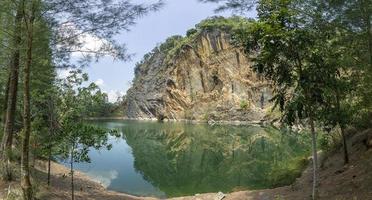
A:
310 117 318 200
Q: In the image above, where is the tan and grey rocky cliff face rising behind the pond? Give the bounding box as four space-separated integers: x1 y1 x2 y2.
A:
125 18 271 121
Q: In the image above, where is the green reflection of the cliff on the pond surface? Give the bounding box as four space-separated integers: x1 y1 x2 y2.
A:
122 123 309 196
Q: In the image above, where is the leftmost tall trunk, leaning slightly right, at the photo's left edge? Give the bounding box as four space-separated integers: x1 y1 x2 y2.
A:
0 3 23 181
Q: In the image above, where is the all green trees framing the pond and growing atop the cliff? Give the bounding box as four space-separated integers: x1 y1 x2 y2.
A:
0 0 372 200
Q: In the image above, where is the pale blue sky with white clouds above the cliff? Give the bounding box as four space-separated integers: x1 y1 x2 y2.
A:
60 0 256 102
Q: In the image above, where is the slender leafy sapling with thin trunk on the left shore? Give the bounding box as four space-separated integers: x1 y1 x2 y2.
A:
57 70 111 200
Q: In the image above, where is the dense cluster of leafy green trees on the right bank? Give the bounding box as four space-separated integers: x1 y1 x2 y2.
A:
202 0 372 198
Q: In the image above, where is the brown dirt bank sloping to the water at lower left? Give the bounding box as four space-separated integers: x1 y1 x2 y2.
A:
0 161 154 200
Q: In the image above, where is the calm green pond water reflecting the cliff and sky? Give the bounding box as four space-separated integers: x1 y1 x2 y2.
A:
65 120 310 198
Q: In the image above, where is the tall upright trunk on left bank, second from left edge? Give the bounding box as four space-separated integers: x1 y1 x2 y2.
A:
21 4 34 200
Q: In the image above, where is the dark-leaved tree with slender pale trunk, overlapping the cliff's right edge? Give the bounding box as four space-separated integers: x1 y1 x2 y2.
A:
201 0 327 199
